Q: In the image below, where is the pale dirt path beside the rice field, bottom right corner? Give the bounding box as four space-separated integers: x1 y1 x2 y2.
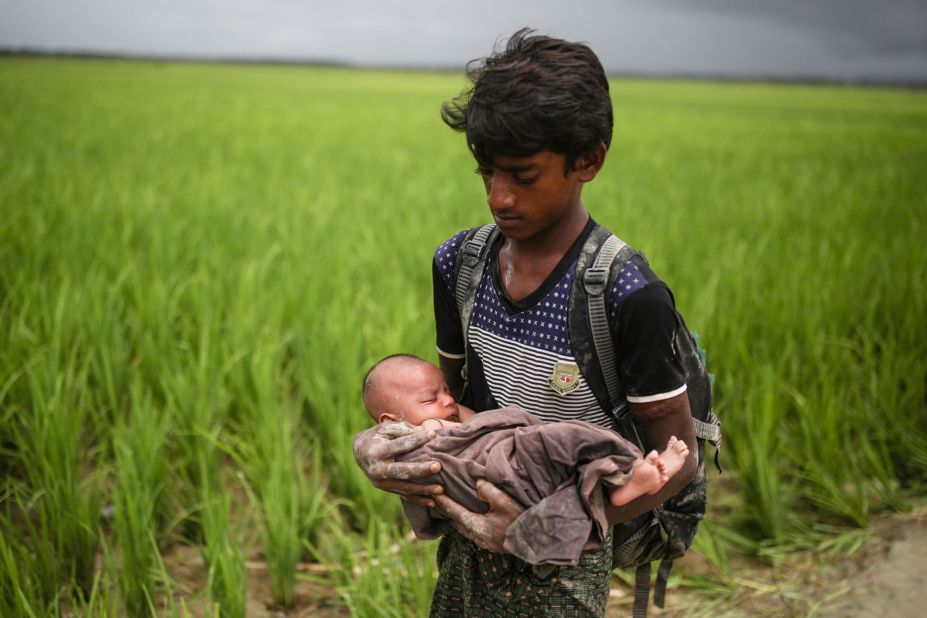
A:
608 506 927 618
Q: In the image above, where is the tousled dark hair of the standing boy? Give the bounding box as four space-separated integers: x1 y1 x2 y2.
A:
441 28 613 173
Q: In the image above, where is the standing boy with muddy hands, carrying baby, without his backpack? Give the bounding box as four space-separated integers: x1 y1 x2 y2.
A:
354 30 707 616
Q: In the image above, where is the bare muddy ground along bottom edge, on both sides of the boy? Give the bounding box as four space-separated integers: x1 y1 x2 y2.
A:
165 505 927 618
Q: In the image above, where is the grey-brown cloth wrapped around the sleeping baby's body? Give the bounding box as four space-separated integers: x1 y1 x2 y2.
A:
397 406 641 566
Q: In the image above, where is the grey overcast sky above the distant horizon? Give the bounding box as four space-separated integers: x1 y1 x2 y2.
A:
0 0 927 82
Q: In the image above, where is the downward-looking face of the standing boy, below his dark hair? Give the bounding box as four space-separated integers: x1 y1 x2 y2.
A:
477 149 604 240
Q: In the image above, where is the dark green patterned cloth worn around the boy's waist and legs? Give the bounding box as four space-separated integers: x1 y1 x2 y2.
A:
431 532 612 618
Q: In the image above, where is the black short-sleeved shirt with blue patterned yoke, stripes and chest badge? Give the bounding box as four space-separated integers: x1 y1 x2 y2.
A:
432 218 686 427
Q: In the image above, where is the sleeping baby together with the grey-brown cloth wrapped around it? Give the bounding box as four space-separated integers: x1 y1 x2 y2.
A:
364 354 688 566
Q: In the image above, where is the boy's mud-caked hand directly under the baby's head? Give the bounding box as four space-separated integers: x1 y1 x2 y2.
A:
354 422 444 507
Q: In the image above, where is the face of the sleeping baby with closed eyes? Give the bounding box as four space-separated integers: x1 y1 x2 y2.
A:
378 363 460 425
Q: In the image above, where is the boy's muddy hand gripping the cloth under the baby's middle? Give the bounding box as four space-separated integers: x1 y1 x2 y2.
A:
435 480 524 554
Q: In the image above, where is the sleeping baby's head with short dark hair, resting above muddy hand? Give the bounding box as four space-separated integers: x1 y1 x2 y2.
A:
364 354 460 425
